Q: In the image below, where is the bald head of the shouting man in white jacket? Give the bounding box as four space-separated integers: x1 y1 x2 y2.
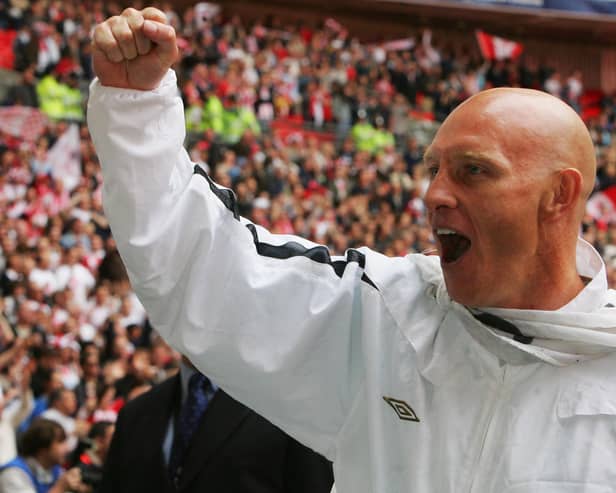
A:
425 88 596 308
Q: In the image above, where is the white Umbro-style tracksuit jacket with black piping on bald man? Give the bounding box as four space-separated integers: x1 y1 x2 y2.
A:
88 72 616 493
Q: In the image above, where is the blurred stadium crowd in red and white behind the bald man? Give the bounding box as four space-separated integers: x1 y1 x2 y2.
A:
0 0 616 488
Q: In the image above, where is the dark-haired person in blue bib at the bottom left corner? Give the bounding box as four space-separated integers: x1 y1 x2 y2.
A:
0 418 91 493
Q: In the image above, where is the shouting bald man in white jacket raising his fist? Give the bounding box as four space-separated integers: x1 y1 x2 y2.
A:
88 9 616 493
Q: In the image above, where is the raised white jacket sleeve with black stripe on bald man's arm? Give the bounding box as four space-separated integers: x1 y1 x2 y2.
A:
88 71 374 455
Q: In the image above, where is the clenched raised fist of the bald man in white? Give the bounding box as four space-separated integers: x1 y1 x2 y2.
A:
92 7 178 91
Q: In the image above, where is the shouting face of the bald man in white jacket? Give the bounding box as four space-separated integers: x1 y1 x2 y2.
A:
425 96 545 308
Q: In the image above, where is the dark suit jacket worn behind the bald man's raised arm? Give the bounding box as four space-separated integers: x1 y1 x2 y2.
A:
101 375 333 493
